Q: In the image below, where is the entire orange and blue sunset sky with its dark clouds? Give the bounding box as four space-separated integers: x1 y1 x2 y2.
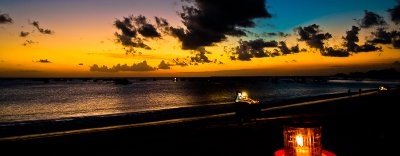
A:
0 0 400 77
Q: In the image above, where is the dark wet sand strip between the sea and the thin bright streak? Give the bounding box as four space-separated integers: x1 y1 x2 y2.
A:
0 89 375 137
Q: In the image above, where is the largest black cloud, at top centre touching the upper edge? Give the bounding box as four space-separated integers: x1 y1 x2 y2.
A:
170 0 271 50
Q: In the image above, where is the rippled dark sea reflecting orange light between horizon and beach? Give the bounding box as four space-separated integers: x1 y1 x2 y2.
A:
0 78 397 123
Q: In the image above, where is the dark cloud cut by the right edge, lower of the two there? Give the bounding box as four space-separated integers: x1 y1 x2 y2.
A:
368 28 400 48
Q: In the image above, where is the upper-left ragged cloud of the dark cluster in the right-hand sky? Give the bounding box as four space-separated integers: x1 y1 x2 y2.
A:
294 24 332 51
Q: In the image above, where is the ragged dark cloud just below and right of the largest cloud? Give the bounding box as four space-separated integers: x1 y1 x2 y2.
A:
231 39 278 61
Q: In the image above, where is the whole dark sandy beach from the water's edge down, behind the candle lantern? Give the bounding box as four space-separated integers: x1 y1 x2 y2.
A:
0 89 400 156
